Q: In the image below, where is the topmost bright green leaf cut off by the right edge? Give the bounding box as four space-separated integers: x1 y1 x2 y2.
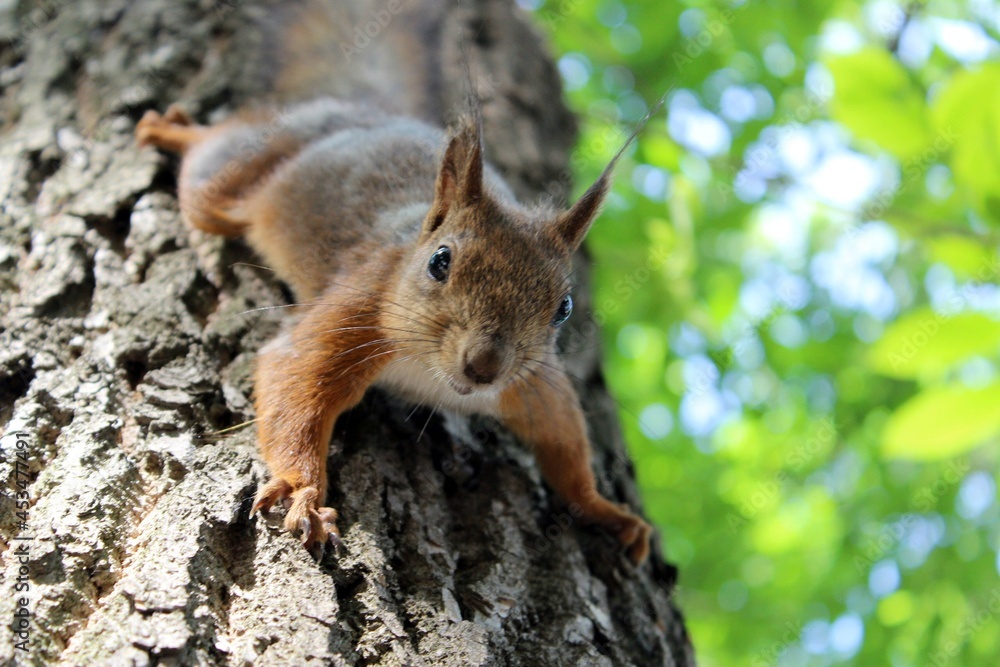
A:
932 63 1000 223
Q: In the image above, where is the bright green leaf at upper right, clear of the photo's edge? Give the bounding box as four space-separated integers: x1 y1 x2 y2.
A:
827 47 931 160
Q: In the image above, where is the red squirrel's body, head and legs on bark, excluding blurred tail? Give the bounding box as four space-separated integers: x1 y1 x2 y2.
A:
136 99 651 564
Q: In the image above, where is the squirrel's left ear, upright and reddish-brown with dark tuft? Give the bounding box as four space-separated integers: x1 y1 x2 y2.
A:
424 120 483 232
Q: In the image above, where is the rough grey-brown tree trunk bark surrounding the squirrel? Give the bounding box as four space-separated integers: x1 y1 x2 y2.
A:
0 0 693 666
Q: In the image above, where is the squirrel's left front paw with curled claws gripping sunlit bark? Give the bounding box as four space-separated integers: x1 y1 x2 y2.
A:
251 477 340 558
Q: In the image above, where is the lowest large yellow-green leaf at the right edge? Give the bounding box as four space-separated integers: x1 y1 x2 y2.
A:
882 383 1000 461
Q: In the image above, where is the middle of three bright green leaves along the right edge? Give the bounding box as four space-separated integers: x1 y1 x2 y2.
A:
868 310 1000 379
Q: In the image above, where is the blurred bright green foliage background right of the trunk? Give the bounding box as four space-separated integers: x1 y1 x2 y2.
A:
519 0 1000 667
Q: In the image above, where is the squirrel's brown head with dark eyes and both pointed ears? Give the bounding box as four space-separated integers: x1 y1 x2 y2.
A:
387 117 613 395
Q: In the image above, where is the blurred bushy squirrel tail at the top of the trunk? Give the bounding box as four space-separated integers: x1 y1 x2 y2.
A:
231 0 447 124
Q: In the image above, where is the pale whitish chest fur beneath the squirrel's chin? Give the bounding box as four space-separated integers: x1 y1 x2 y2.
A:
375 358 500 417
